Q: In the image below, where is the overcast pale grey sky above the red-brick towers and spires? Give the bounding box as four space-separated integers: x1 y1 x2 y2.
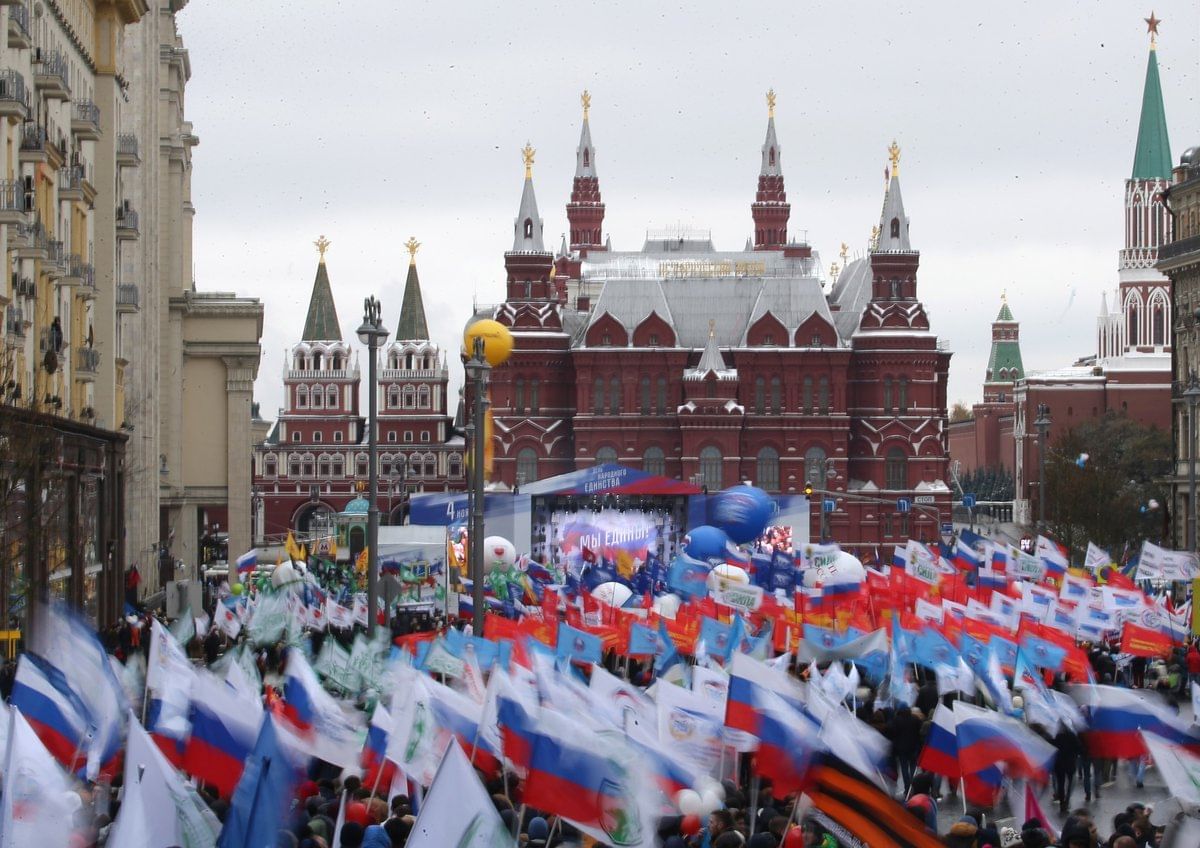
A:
180 0 1200 417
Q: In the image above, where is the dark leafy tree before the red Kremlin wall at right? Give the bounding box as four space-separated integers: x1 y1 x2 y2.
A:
1045 413 1171 557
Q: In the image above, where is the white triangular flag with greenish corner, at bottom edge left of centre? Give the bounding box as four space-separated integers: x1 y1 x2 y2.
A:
408 741 512 848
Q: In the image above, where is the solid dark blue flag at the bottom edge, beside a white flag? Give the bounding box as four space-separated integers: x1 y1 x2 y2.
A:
217 715 301 848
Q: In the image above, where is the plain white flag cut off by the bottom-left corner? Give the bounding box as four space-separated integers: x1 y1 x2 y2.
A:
0 709 74 848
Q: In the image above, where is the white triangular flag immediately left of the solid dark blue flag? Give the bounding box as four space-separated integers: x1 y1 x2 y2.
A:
108 717 220 848
